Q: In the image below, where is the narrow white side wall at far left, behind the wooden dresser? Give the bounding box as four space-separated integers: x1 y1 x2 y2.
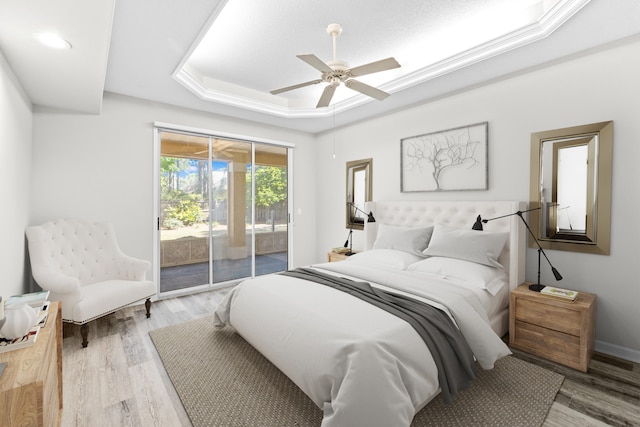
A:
0 52 33 298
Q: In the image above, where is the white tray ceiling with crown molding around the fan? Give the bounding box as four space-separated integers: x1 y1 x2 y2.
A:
0 0 640 133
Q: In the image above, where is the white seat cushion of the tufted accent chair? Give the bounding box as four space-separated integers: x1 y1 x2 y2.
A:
68 280 156 323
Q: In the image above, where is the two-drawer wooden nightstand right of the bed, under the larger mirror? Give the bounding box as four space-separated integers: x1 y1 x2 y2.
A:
509 283 596 372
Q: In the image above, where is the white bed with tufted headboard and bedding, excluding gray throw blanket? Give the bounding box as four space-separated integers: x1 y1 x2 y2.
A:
214 201 524 427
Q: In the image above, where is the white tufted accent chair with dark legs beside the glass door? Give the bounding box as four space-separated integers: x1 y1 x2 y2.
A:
26 219 156 347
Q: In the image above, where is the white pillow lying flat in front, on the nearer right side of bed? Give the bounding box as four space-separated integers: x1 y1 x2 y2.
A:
407 257 507 295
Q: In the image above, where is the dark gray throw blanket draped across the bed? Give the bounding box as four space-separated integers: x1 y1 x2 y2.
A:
280 268 477 403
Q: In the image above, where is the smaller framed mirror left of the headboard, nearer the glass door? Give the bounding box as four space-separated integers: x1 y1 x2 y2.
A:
345 159 373 230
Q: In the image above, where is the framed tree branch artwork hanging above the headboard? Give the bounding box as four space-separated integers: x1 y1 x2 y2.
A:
400 122 489 193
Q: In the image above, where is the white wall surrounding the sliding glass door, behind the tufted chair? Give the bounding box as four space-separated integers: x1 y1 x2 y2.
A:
31 94 316 277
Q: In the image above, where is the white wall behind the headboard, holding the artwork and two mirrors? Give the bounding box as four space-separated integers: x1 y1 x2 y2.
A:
317 38 640 361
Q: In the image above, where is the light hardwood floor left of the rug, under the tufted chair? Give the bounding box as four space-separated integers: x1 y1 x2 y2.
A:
61 291 224 427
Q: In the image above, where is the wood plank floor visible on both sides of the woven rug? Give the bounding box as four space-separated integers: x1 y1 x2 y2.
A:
57 291 640 427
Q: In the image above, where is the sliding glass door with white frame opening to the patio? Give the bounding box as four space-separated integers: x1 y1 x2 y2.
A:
157 130 289 294
